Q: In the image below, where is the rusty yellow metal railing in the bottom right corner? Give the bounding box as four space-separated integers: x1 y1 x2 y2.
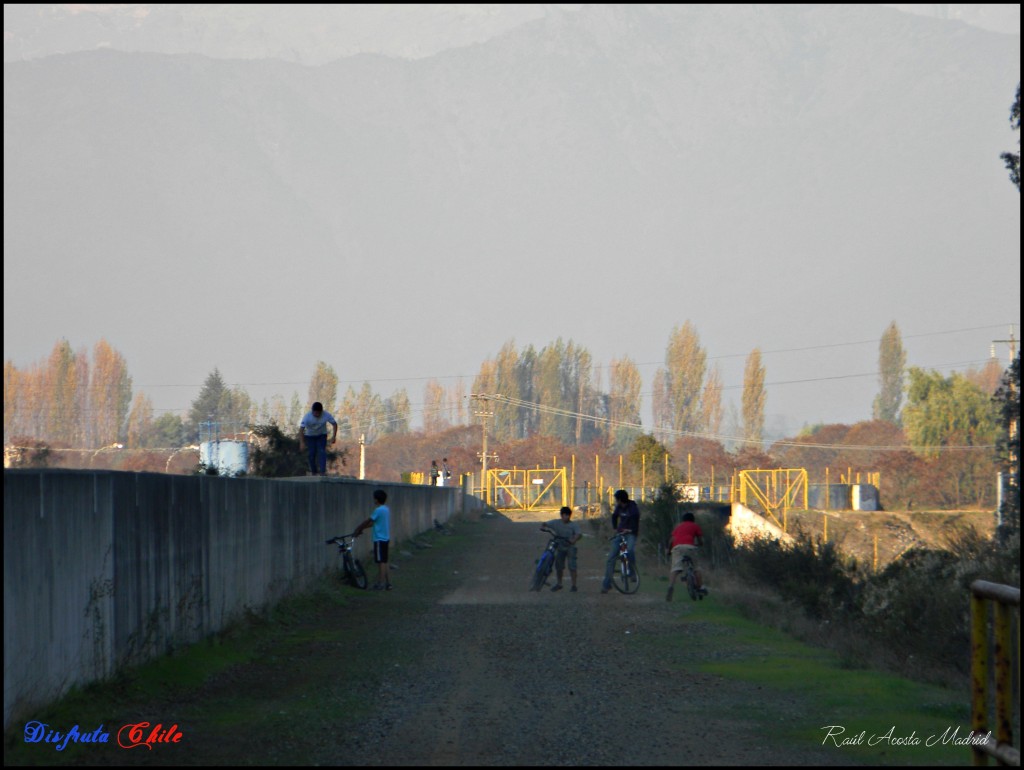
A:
971 581 1021 767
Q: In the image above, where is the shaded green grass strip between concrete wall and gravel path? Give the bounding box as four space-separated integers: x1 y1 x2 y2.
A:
4 523 474 766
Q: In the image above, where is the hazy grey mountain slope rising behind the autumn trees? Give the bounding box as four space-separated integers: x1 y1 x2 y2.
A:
4 5 1020 430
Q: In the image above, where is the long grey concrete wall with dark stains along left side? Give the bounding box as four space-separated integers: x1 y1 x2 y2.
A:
4 470 482 729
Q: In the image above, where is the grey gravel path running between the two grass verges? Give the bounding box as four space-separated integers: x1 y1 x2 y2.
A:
335 517 839 766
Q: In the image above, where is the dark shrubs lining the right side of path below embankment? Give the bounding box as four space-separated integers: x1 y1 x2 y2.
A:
732 520 1020 682
